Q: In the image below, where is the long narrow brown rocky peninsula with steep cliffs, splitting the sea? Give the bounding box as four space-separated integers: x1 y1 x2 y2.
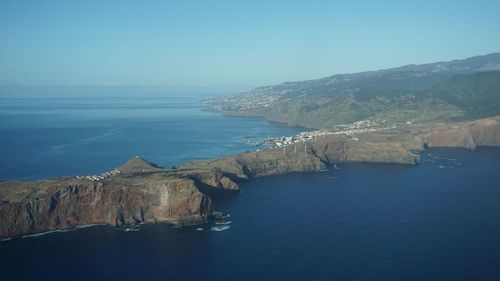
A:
0 116 500 238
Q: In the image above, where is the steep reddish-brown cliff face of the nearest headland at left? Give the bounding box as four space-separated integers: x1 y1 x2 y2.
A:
0 173 212 237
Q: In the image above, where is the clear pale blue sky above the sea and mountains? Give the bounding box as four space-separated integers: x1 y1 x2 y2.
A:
0 0 500 88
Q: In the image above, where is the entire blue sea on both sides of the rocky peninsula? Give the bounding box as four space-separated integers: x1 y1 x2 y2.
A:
0 86 500 280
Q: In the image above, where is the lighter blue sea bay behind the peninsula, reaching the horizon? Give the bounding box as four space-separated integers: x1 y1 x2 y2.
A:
0 87 299 180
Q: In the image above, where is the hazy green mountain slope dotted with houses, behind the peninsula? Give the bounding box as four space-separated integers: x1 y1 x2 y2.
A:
204 53 500 129
